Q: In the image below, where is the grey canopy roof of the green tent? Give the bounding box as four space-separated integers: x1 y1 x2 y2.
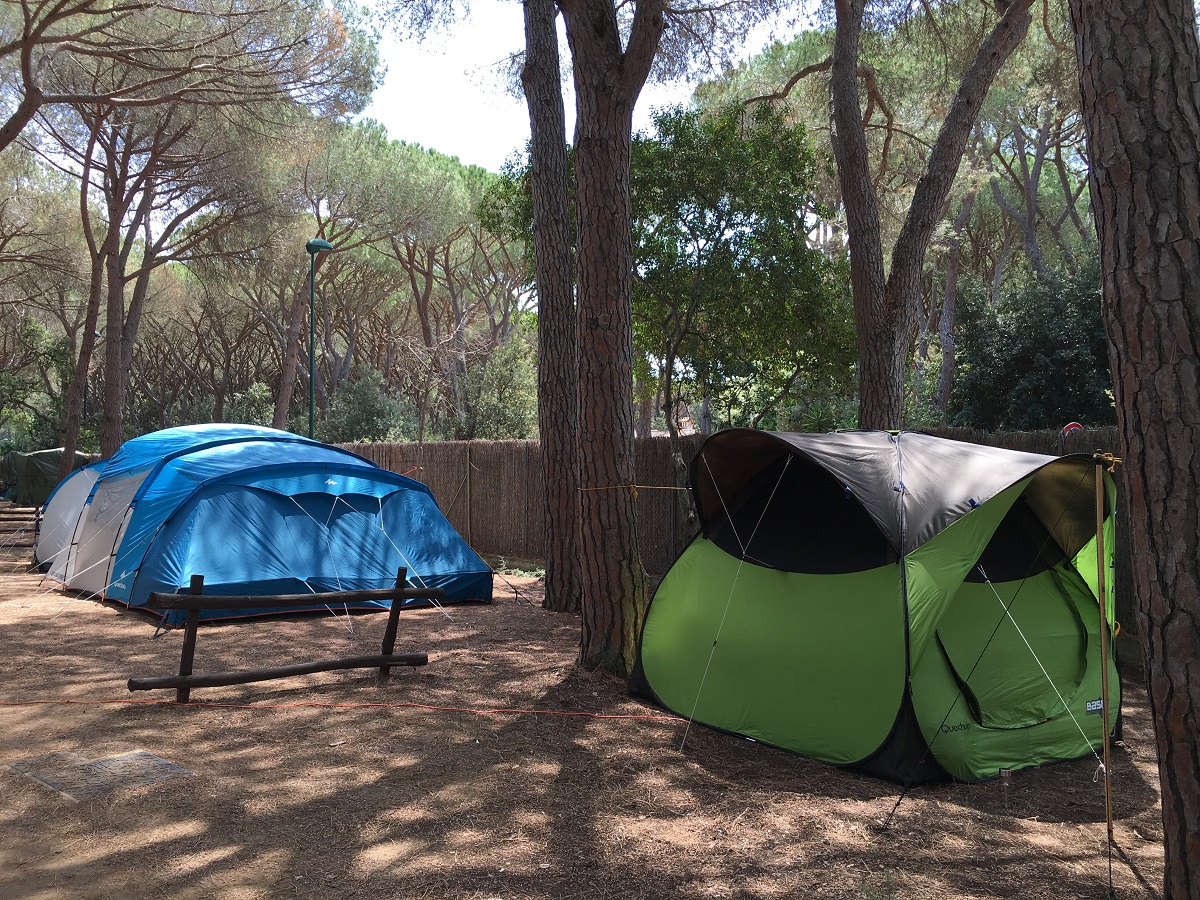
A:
691 428 1096 554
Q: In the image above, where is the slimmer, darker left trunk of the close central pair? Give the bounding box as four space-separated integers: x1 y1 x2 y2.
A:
521 0 581 612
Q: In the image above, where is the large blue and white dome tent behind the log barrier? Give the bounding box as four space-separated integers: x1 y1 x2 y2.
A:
36 425 492 624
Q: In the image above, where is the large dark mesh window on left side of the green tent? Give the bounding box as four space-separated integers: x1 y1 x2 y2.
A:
704 455 895 575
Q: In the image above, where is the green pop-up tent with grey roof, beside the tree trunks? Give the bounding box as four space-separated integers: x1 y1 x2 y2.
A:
631 428 1121 784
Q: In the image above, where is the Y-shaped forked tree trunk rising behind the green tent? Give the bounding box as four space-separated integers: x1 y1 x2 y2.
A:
829 0 1032 428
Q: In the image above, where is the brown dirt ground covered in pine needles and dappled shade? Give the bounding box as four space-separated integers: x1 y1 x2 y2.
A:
0 508 1162 900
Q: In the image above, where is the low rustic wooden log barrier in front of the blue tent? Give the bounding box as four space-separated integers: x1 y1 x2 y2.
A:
128 568 445 703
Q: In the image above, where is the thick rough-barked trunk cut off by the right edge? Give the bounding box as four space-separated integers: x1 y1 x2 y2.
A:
1070 0 1200 900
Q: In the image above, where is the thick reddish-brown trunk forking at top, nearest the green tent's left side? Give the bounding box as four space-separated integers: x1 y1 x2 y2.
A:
560 0 664 676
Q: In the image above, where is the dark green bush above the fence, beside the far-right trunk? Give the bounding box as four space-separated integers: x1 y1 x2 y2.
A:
950 260 1116 431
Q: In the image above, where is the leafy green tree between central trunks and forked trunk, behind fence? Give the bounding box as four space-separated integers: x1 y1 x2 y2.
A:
632 104 854 425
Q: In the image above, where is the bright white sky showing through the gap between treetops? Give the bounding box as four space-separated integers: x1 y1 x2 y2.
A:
364 0 748 172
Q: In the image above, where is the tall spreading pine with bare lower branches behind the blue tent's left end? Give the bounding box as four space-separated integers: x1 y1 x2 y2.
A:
18 2 376 468
